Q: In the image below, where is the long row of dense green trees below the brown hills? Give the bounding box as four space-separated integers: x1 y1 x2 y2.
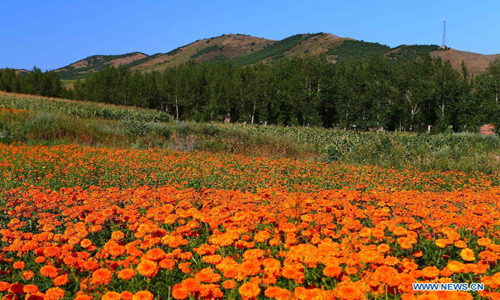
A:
0 55 500 132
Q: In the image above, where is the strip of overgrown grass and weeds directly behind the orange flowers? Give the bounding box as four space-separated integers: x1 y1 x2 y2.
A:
0 95 500 174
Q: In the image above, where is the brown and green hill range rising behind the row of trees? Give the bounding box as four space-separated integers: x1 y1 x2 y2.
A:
52 33 500 79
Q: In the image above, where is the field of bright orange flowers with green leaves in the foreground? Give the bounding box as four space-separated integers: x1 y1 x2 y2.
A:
0 144 500 299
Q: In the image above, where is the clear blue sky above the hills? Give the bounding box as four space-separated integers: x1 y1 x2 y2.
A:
0 0 500 70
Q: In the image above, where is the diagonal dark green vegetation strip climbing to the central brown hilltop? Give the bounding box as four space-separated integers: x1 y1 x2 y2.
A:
231 34 318 66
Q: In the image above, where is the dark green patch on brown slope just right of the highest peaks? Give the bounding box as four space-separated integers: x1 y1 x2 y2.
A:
327 41 391 59
